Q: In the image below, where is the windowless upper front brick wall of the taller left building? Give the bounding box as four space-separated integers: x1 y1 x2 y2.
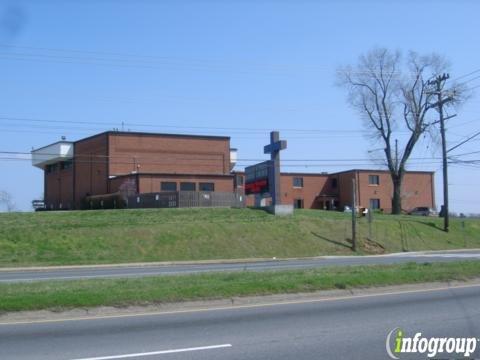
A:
109 133 230 175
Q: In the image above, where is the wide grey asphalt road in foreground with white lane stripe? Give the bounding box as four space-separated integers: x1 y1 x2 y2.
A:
0 285 480 360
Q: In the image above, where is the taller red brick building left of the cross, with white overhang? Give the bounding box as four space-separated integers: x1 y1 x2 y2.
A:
32 131 235 209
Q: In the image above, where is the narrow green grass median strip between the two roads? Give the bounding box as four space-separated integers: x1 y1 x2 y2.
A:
0 261 480 312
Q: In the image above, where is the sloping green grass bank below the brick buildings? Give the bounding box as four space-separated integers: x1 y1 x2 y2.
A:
0 209 480 267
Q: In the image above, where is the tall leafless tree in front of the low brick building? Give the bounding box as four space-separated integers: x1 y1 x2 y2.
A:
337 48 454 214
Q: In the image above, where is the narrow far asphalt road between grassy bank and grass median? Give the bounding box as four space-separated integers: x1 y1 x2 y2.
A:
0 251 480 283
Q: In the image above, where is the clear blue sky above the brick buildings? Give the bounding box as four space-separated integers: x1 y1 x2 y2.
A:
0 0 480 213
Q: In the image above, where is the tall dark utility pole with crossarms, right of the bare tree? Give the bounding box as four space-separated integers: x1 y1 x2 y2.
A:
428 74 452 232
